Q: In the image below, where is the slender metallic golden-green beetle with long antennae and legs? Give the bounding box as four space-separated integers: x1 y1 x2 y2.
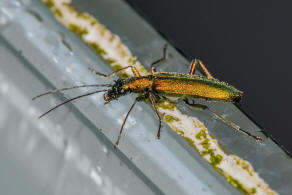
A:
33 45 262 146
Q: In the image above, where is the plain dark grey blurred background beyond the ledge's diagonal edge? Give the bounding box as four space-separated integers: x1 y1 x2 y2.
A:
127 0 292 152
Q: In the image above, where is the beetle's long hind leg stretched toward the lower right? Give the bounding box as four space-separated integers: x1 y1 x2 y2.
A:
183 98 263 141
